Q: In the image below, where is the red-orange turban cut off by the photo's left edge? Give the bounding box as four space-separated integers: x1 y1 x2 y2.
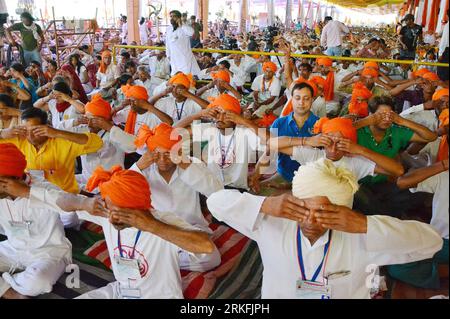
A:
0 143 27 177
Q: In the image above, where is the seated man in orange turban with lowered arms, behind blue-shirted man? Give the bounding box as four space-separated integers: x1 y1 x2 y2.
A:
249 61 281 118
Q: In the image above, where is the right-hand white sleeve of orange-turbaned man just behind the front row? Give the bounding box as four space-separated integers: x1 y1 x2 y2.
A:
180 159 223 197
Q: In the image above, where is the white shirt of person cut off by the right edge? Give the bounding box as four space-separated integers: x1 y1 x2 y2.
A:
410 171 449 239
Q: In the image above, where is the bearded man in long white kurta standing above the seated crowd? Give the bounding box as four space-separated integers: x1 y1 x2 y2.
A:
166 11 200 75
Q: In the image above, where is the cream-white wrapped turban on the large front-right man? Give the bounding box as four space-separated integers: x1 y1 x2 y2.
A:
292 158 359 208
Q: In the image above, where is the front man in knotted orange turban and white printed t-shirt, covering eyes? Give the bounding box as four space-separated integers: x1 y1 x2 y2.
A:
30 166 216 299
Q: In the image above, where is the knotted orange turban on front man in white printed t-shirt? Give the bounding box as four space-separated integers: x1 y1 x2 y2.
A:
86 166 152 209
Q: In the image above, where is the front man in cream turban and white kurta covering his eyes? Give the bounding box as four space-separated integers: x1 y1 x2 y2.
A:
207 160 442 299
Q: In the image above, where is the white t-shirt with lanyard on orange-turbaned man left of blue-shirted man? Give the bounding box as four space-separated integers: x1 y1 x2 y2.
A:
192 123 265 189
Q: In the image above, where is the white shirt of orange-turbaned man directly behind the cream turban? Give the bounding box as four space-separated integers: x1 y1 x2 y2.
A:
291 146 376 180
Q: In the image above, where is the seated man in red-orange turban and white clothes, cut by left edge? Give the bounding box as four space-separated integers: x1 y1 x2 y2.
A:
0 143 72 299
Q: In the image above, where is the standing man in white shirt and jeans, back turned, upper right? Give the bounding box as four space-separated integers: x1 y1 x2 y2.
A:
320 17 350 56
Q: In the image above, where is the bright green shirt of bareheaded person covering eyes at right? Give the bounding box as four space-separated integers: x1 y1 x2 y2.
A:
358 124 414 185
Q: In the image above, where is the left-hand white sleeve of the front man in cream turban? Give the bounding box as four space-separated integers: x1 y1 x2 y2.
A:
206 190 266 241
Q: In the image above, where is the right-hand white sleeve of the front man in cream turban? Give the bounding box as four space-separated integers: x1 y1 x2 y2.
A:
364 216 443 266
